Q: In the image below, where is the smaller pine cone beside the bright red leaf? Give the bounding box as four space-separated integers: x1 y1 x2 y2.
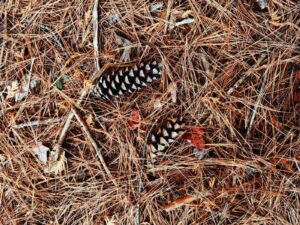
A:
149 119 184 164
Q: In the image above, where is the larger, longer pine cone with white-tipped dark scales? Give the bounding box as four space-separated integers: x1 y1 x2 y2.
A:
92 61 162 99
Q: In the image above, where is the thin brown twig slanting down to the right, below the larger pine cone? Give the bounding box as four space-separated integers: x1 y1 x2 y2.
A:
71 107 118 186
